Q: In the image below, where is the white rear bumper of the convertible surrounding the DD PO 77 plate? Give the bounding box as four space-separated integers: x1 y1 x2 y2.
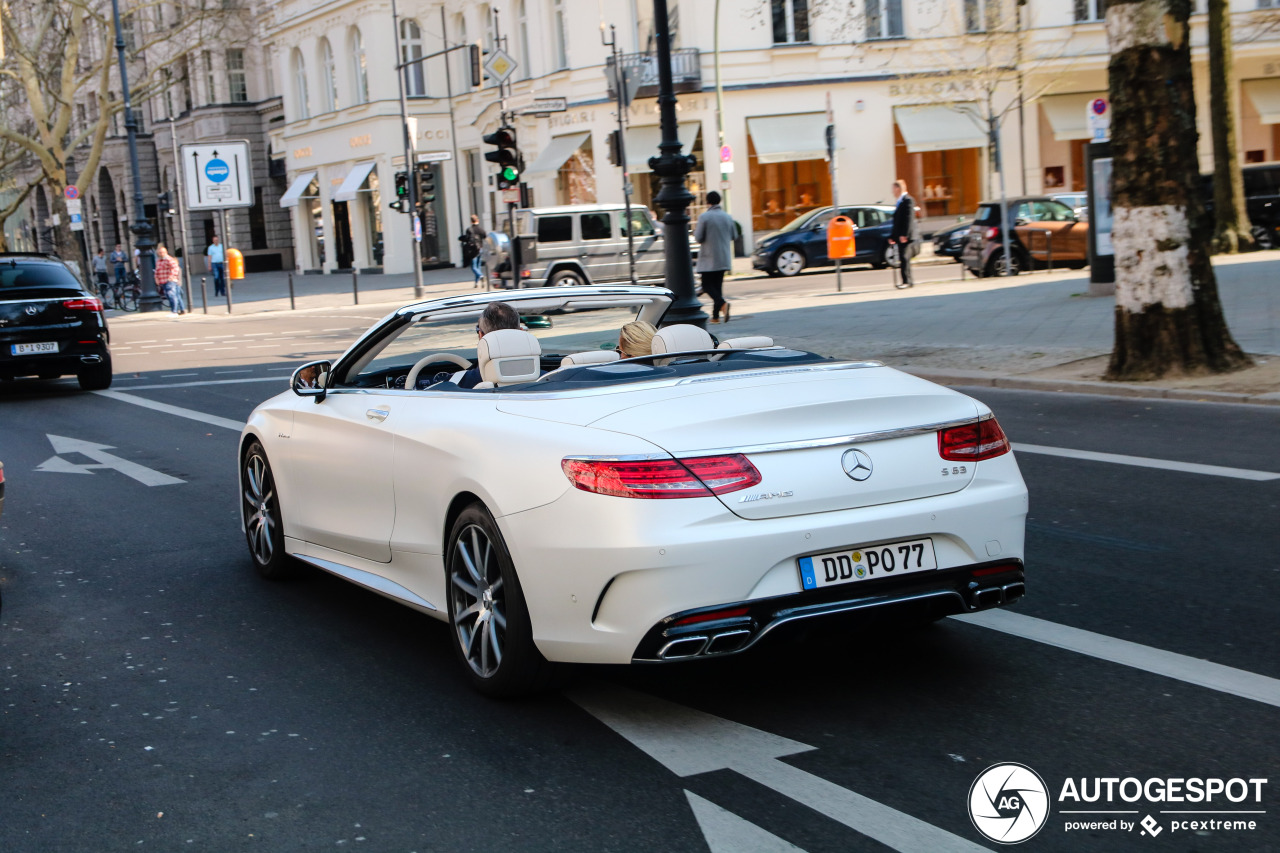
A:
497 453 1027 663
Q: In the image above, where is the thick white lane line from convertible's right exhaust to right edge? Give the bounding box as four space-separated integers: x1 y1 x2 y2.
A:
951 610 1280 707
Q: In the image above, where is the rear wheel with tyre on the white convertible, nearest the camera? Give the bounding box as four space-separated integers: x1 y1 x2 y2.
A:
444 503 561 698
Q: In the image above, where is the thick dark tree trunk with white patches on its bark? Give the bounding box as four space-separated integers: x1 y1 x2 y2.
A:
1106 0 1251 379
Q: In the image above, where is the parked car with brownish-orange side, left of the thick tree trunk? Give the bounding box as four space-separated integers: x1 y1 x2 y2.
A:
960 196 1089 275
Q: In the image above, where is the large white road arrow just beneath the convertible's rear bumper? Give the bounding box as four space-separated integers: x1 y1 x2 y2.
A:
566 684 986 853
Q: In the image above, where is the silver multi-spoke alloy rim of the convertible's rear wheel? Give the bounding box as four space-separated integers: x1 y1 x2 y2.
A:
449 524 507 679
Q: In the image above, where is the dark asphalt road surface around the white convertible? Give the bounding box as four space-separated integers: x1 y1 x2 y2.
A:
0 324 1280 853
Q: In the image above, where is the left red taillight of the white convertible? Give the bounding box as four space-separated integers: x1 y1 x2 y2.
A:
561 453 760 498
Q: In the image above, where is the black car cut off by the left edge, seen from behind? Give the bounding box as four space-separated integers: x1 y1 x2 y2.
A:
0 252 111 391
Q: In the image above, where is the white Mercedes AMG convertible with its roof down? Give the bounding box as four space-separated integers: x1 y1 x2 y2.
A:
239 281 1027 695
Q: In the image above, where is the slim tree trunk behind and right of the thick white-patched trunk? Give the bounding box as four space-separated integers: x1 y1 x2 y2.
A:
1208 0 1254 254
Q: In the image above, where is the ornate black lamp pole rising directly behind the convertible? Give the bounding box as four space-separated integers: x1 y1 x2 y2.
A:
649 0 707 328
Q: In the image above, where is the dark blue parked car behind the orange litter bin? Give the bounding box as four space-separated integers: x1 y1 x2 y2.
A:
751 205 893 275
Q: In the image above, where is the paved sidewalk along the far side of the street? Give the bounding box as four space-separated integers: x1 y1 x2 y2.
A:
111 252 1280 405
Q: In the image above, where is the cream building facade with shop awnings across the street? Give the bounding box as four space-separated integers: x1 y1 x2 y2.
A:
261 0 1280 273
